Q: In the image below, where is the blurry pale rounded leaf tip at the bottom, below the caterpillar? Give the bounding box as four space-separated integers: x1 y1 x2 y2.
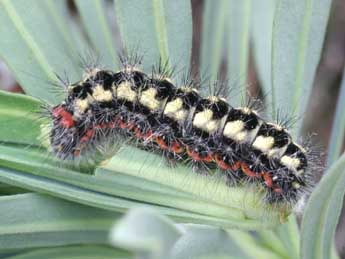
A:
110 208 182 259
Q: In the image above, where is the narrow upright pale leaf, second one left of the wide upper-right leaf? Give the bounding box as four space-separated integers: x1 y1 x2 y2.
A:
227 0 252 107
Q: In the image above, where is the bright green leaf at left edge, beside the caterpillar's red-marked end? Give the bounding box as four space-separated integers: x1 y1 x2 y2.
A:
0 91 41 145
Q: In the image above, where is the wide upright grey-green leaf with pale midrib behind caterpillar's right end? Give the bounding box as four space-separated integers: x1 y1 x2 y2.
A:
272 0 331 131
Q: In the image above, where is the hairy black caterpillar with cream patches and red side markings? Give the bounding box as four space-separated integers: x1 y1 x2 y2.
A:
49 54 313 207
